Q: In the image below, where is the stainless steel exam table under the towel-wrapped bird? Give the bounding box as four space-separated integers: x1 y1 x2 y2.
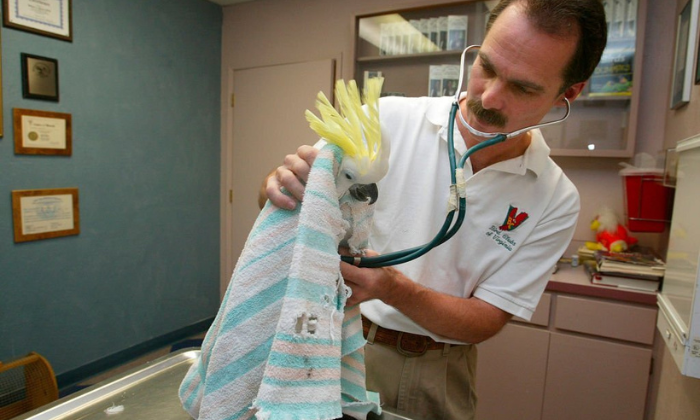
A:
13 349 410 420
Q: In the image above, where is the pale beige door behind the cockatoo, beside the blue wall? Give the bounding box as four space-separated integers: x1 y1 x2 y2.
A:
221 59 335 297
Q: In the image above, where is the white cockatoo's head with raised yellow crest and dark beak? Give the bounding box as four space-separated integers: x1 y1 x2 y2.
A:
306 78 389 204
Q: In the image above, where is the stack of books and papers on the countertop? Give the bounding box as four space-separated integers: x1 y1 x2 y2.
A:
585 248 666 292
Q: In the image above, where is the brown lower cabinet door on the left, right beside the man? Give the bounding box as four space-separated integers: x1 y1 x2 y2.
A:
476 324 550 420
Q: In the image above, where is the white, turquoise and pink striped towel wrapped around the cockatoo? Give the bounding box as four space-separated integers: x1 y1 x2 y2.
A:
180 145 380 420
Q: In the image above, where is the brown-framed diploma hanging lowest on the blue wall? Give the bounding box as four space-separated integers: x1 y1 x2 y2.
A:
12 188 80 242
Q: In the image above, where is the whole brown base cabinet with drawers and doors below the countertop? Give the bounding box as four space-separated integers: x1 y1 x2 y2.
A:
476 293 656 420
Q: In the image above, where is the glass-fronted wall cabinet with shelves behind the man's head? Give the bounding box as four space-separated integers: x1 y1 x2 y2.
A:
354 0 647 157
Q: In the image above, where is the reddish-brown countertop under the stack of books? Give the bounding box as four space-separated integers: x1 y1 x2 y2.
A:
546 263 656 306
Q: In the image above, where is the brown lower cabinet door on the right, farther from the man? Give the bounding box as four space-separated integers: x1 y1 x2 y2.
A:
542 333 651 420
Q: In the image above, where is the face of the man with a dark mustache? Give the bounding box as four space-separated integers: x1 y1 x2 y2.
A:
467 4 584 138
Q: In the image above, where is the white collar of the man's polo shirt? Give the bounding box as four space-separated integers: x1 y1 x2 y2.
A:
426 96 550 176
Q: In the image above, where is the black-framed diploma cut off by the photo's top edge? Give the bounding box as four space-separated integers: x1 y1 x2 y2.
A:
2 0 73 42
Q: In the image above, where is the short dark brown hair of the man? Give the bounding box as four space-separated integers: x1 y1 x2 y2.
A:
486 0 608 92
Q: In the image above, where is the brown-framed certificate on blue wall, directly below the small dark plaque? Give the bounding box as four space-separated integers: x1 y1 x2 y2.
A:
12 108 73 156
